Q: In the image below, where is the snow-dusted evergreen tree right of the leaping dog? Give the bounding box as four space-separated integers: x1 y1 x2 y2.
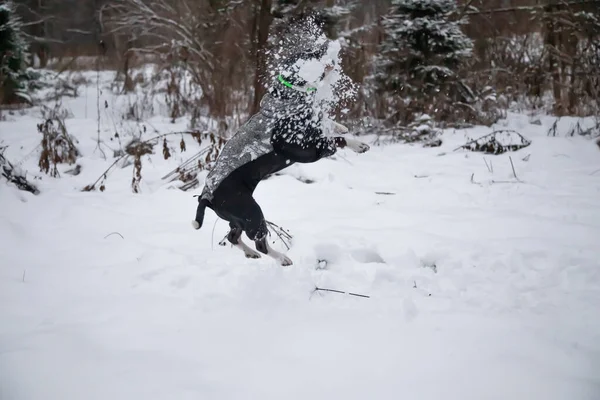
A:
375 0 472 122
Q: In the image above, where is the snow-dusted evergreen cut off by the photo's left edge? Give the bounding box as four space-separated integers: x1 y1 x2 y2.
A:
0 0 29 104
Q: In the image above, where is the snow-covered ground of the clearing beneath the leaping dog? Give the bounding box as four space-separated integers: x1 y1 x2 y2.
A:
0 72 600 400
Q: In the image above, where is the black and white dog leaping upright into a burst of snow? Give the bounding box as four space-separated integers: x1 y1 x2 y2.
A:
192 43 369 265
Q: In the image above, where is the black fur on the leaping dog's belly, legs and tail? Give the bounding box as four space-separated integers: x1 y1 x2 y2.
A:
195 47 346 265
